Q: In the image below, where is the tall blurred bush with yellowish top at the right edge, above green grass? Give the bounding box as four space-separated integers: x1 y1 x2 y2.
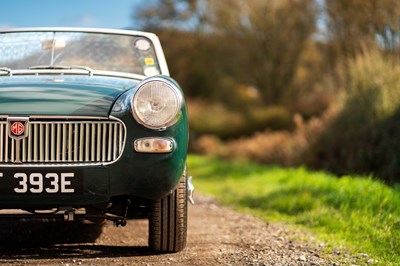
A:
308 51 400 183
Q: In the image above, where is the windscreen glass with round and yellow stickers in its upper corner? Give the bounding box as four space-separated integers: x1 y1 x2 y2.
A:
0 31 160 76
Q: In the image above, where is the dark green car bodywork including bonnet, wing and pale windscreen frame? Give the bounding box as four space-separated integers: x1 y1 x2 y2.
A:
0 28 188 210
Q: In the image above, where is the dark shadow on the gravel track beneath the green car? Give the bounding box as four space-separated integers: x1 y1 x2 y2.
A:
0 219 157 263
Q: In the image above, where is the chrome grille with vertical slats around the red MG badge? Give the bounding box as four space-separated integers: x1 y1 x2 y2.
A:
0 120 125 164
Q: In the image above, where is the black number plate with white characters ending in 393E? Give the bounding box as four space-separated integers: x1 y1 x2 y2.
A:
0 168 83 195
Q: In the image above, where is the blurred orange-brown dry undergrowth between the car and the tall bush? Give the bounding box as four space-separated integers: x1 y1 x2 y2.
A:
196 106 338 166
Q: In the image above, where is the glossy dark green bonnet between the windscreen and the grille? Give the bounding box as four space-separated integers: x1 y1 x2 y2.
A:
0 76 138 117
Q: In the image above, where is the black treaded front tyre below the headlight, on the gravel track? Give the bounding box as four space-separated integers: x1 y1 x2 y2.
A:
149 171 187 253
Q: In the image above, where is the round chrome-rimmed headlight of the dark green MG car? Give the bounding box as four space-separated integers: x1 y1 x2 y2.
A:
131 77 183 130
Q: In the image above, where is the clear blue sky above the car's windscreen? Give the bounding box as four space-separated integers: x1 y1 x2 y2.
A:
0 0 147 29
